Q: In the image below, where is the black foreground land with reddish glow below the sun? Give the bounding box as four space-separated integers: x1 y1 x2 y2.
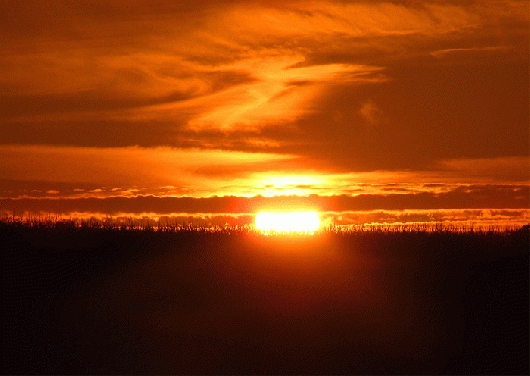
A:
0 225 529 374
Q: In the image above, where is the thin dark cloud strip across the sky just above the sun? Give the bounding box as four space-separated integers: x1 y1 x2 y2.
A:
0 185 530 215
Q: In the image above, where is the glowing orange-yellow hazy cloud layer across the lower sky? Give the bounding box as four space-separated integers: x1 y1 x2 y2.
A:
0 145 530 198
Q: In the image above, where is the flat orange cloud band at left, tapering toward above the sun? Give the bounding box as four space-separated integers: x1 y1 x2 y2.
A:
0 145 297 195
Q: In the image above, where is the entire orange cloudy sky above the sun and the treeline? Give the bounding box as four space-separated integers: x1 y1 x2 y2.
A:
0 0 530 224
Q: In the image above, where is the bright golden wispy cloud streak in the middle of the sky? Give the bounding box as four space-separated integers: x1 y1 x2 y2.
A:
188 56 380 131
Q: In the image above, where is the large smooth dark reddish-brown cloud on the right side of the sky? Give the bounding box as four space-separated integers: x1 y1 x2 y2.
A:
263 61 529 171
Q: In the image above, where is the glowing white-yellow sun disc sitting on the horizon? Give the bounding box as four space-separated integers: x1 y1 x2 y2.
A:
256 211 320 232
